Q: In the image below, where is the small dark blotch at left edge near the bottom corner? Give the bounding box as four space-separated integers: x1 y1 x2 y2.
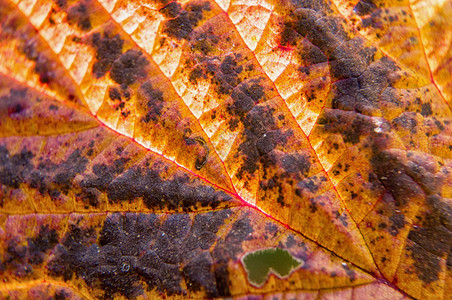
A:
0 225 58 277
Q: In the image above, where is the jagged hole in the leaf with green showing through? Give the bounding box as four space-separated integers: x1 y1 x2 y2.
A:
242 248 303 287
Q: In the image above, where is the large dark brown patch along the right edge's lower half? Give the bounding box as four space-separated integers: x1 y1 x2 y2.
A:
369 150 452 284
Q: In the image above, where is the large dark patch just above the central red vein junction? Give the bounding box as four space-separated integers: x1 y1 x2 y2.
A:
230 100 311 205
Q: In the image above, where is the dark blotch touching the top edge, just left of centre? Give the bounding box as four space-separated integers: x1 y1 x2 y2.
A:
160 2 211 40
